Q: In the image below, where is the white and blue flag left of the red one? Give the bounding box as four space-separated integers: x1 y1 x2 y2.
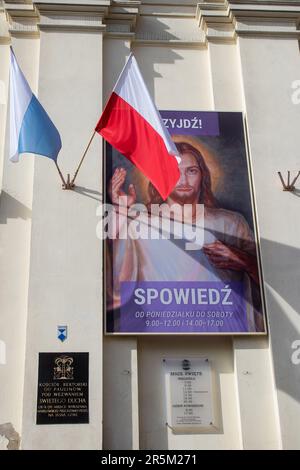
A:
9 48 61 162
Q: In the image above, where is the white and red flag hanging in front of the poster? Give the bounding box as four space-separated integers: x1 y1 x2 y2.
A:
95 54 180 200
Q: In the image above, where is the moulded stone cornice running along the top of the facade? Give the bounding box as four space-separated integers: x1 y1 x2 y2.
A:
1 0 300 40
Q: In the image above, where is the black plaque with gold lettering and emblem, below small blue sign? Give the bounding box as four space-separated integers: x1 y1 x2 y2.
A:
36 352 89 424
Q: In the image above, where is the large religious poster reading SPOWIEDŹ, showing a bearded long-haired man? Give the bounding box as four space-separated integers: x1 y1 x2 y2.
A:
101 111 266 334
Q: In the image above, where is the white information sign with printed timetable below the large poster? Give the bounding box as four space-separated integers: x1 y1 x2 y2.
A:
163 358 215 432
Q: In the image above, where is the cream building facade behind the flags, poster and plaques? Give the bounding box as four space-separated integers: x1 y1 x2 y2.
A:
0 0 300 450
